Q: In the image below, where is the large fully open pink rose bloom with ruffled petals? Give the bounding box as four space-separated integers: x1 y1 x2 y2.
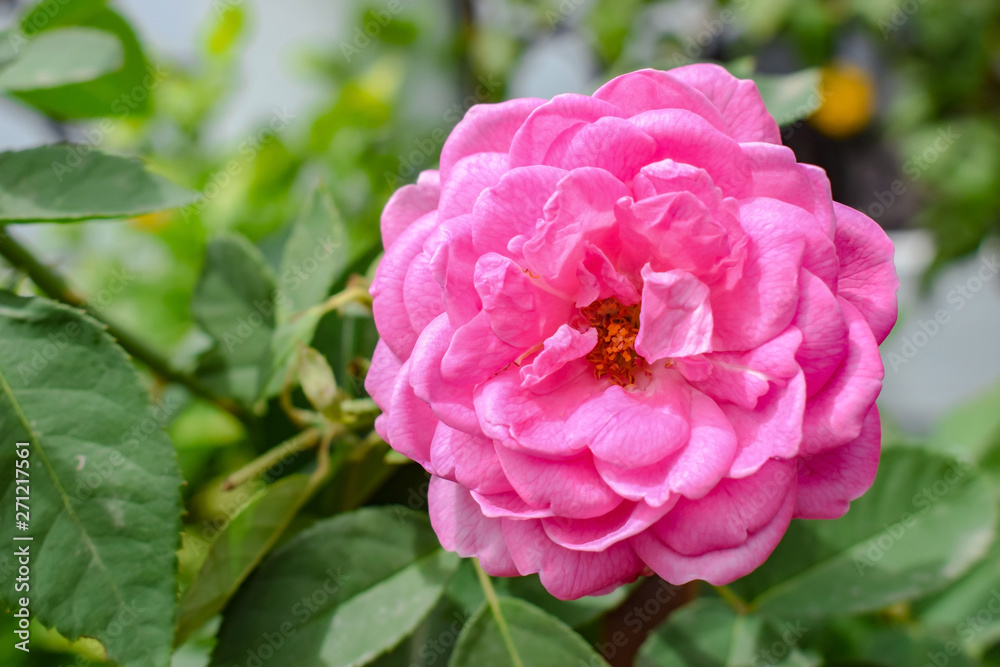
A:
366 65 898 599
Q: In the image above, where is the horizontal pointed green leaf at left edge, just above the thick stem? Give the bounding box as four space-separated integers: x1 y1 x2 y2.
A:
0 145 191 222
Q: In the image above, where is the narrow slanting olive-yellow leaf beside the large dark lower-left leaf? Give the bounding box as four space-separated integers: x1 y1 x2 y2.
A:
175 475 311 645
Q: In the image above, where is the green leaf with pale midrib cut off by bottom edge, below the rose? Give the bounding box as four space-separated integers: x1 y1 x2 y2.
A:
448 597 607 667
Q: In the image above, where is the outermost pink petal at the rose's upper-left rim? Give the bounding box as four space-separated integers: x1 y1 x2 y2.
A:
441 98 545 181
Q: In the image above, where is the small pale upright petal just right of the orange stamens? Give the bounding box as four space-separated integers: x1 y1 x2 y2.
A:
635 264 712 363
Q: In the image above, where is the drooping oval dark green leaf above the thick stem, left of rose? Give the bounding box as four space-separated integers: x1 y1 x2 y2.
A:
191 235 281 406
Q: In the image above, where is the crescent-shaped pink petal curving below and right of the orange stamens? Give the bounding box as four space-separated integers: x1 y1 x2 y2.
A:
596 392 736 507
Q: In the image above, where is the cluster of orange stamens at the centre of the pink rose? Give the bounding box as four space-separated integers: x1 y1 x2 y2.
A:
580 298 646 387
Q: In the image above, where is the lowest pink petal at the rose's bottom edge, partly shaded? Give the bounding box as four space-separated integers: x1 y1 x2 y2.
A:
503 519 643 600
